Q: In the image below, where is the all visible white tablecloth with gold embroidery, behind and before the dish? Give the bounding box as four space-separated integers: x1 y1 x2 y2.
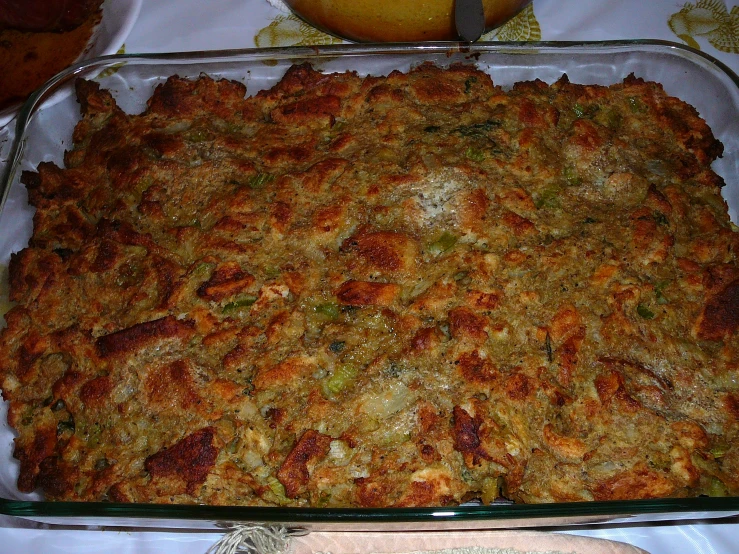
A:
0 0 739 554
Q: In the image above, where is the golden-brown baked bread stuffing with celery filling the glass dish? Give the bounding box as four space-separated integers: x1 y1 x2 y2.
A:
0 61 739 507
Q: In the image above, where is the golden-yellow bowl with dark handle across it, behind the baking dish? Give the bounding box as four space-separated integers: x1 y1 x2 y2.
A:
286 0 531 42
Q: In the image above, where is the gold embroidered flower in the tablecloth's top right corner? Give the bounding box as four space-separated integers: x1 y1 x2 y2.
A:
667 0 739 54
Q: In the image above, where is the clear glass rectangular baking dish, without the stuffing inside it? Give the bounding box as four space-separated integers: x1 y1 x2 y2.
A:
0 41 739 530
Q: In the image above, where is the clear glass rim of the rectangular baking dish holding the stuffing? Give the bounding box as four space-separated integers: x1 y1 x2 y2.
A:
0 39 739 525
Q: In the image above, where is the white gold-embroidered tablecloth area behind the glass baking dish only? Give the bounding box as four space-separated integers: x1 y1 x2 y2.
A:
126 0 739 72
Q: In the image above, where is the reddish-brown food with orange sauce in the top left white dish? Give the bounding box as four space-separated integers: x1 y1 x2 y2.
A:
0 11 101 110
